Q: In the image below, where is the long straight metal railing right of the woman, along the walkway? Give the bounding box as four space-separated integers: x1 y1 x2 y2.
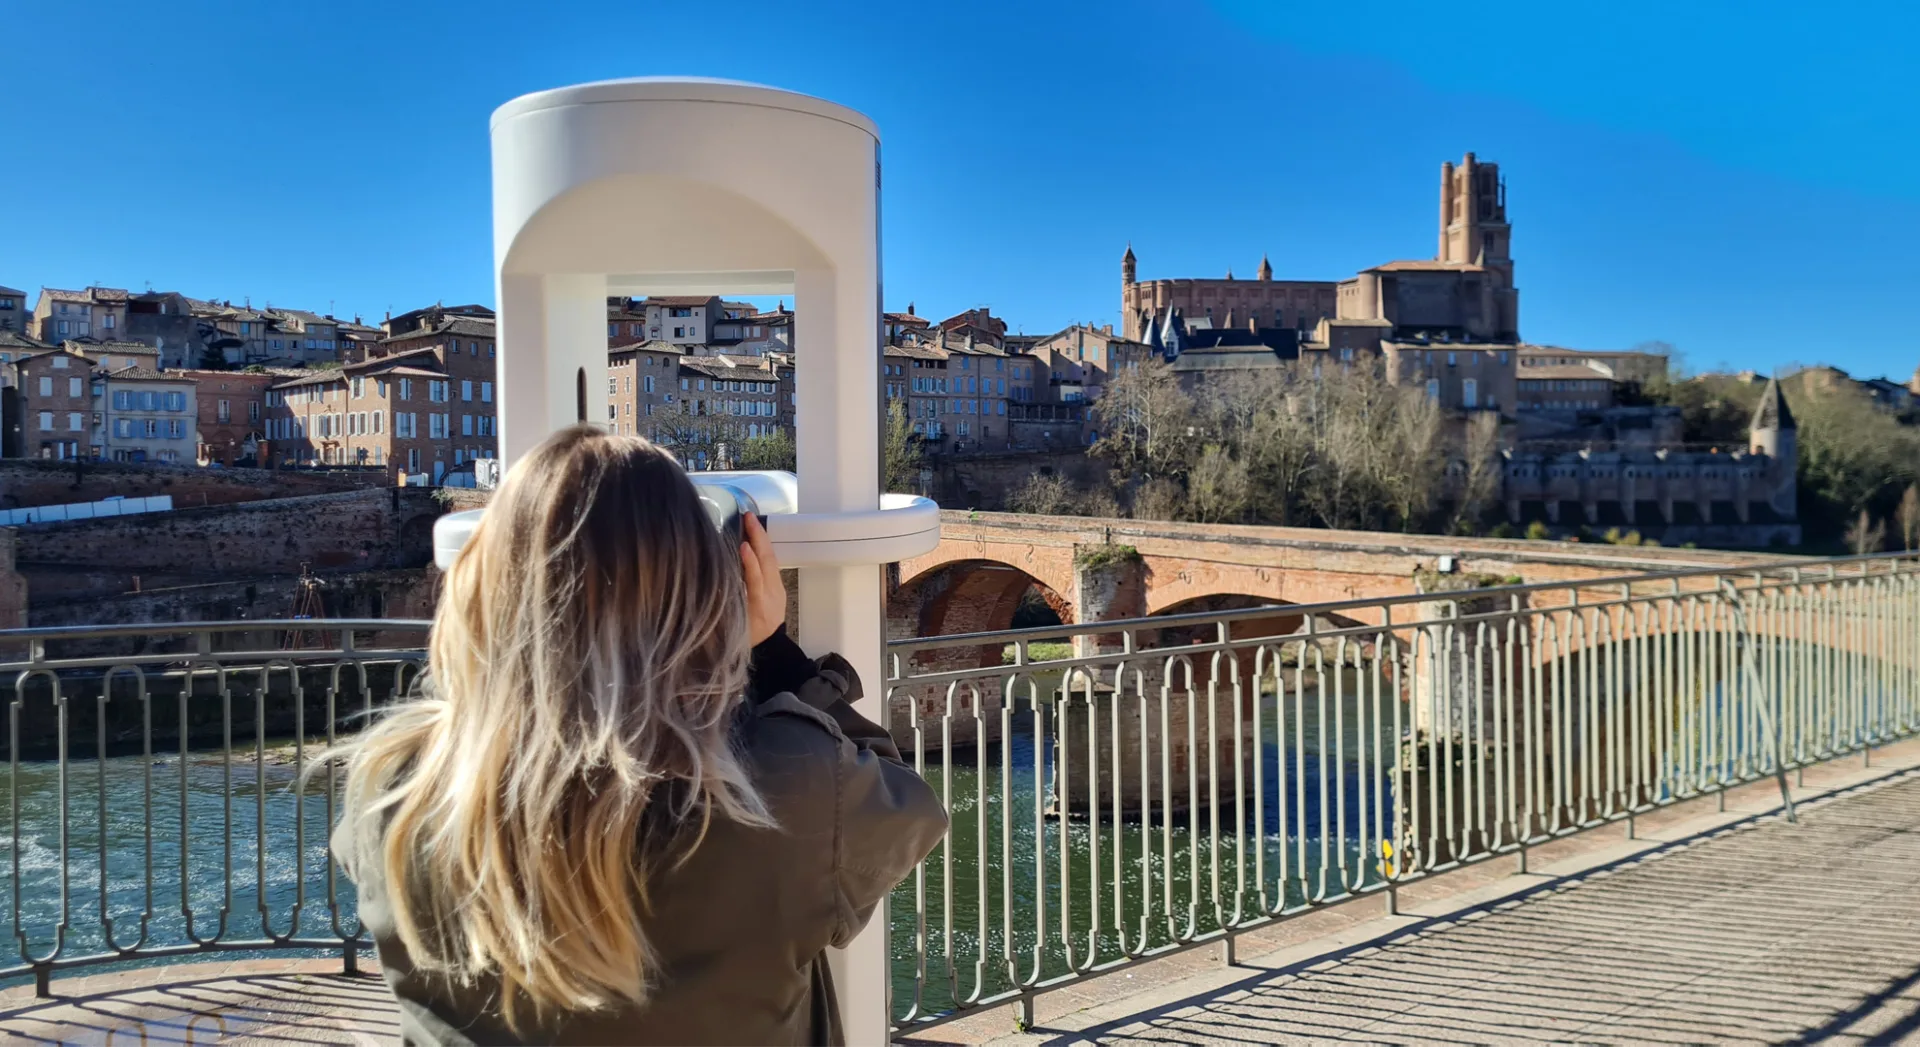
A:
887 553 1920 1030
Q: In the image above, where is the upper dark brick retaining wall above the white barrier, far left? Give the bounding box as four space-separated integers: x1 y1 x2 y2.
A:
0 459 386 509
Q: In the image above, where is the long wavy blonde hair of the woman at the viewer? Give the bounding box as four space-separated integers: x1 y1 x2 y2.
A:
334 426 772 1028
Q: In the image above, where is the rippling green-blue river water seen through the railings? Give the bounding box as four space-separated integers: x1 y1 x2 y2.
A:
0 683 1390 1016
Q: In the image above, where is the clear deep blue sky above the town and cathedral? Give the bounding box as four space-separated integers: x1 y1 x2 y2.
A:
0 0 1920 378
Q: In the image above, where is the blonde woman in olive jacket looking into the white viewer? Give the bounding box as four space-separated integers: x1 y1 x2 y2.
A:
336 426 947 1043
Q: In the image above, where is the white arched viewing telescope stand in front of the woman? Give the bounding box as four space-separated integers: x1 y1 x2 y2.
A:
434 79 941 1043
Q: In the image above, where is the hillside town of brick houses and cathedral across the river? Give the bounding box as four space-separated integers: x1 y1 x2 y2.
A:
0 154 1920 610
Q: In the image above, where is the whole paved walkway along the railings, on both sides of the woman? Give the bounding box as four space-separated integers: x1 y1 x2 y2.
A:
0 759 1920 1045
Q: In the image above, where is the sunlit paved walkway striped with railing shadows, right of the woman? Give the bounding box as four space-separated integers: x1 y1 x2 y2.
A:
983 774 1920 1045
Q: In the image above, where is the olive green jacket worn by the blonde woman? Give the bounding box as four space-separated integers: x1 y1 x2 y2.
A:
359 632 947 1045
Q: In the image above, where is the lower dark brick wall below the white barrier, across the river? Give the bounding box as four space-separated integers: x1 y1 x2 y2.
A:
15 488 442 607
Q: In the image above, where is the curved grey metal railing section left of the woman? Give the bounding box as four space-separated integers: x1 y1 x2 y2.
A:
0 621 428 995
